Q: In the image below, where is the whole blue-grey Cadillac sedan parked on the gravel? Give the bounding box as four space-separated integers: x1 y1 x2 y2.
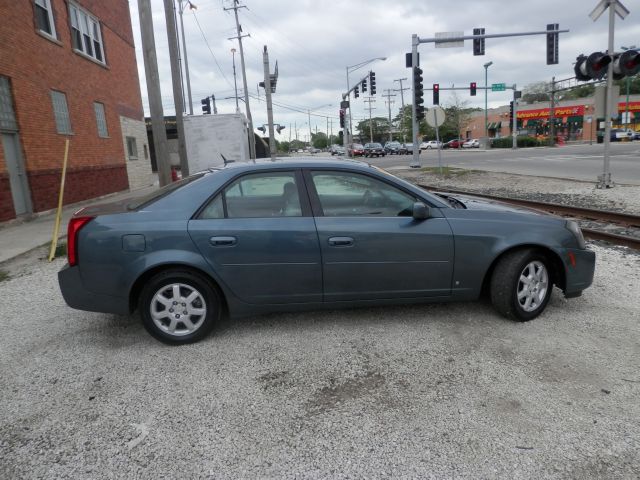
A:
58 159 595 343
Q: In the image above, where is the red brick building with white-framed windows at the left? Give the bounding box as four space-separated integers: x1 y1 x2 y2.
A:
0 0 154 221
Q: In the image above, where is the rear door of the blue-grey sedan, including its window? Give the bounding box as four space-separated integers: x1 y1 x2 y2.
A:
189 170 322 304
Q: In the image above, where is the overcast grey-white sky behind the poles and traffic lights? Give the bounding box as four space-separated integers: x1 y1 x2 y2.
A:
130 0 640 140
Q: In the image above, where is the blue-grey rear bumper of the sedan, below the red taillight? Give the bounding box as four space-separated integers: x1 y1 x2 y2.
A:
58 265 129 315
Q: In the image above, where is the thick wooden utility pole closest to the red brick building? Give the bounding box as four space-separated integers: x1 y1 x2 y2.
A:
138 0 171 187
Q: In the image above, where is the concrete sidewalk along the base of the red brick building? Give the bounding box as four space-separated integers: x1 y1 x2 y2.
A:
0 184 158 264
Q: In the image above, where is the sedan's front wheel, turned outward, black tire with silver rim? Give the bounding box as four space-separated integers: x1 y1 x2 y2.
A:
491 249 553 322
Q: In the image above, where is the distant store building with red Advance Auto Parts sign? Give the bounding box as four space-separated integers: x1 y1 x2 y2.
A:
461 95 640 142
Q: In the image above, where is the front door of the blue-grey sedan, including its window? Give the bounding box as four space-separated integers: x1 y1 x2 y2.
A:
305 169 454 302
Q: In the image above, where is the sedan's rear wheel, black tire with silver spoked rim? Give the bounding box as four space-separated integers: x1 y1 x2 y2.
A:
138 269 222 345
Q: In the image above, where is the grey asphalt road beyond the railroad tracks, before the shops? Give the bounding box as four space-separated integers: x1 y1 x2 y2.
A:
362 142 640 185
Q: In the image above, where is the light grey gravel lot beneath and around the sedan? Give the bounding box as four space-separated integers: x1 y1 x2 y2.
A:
0 245 640 479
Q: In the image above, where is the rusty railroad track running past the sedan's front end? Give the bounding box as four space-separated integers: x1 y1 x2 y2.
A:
418 184 640 250
